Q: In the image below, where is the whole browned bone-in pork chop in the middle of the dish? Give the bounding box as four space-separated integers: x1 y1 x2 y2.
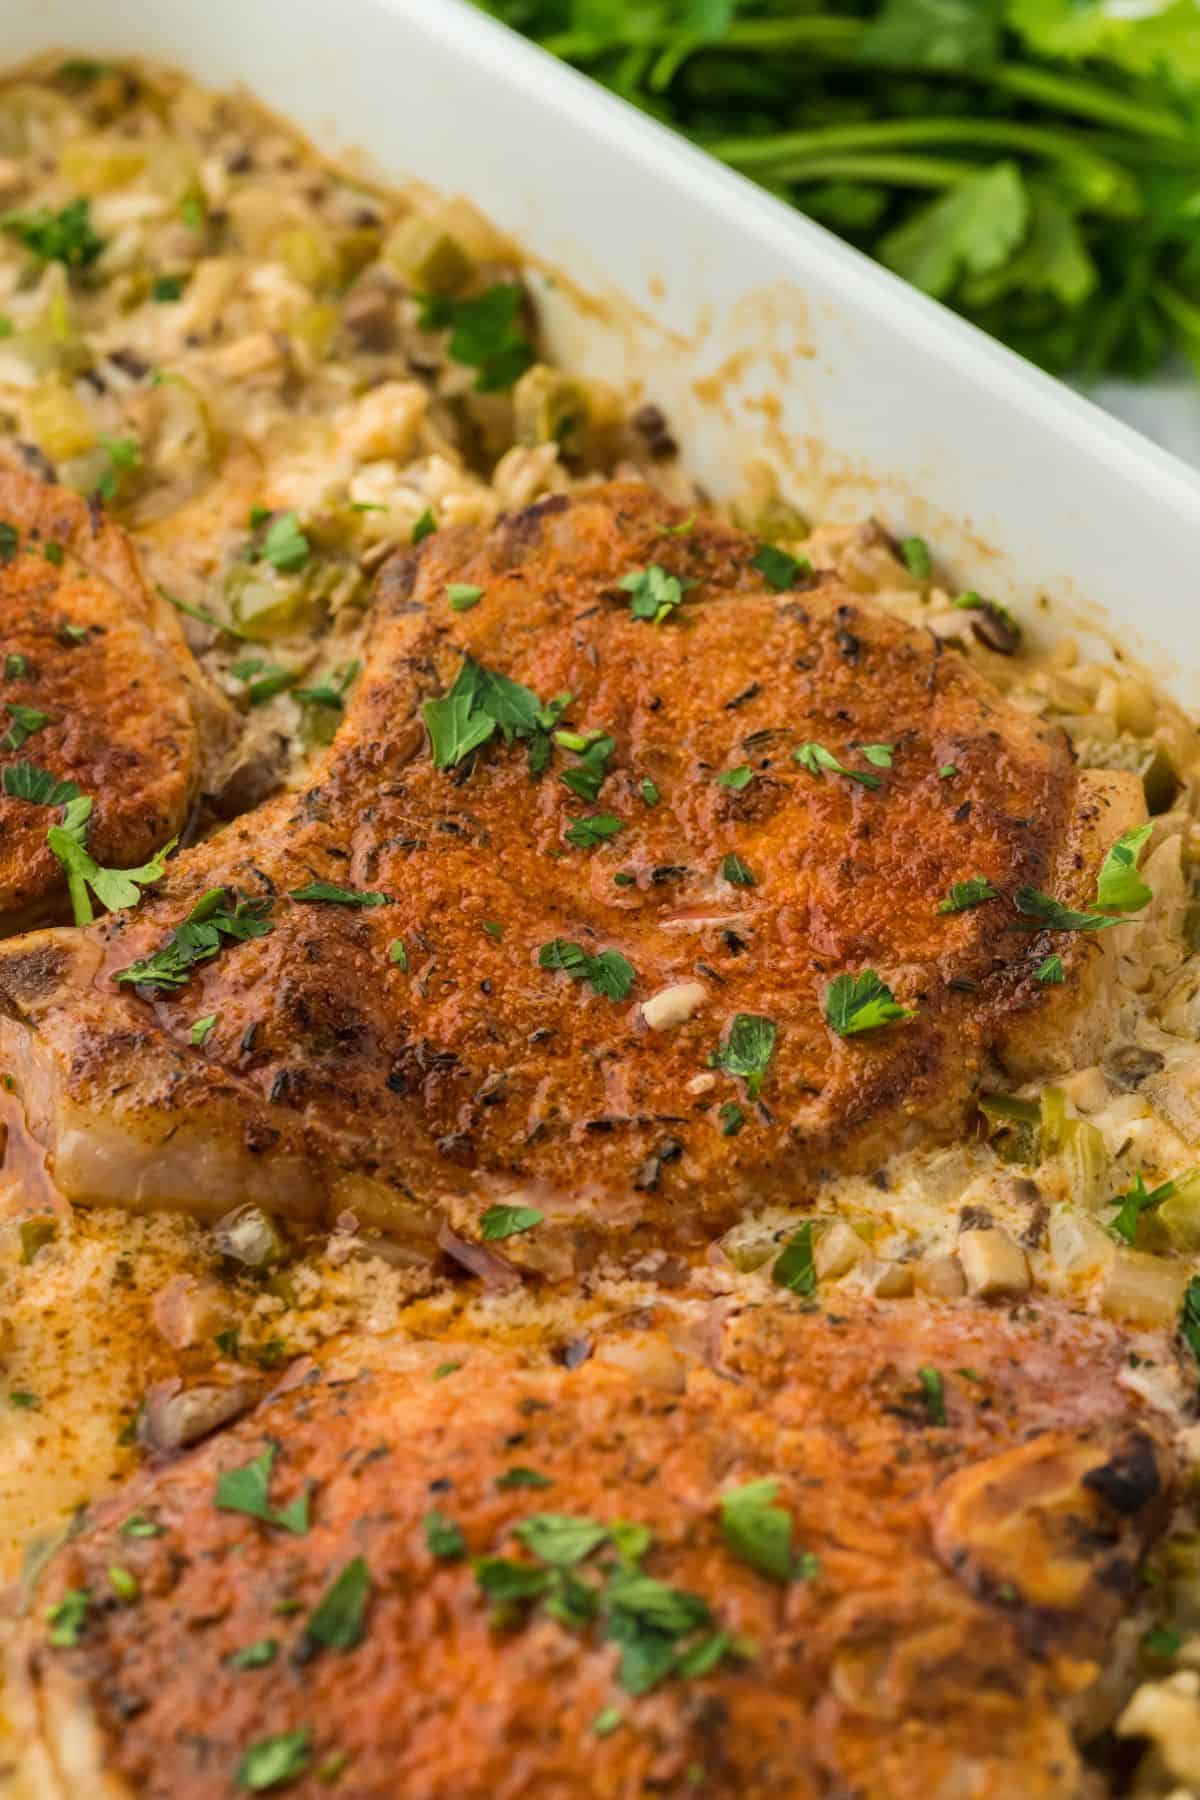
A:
0 484 1132 1256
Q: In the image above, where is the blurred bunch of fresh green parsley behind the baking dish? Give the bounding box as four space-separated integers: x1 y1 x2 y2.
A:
480 0 1200 376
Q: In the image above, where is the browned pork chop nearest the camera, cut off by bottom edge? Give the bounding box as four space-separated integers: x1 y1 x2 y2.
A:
11 1303 1171 1800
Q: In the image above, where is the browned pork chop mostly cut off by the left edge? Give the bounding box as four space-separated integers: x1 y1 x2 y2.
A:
0 468 228 931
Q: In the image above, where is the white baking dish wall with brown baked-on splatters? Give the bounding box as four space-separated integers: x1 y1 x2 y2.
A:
0 0 1200 702
